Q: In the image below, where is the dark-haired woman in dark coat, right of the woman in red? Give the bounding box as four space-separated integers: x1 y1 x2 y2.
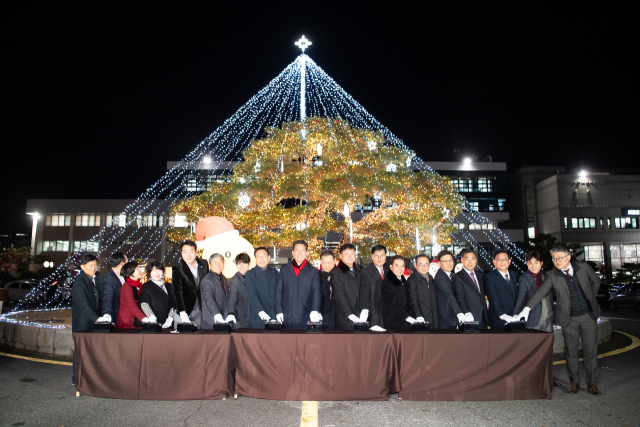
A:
140 261 175 329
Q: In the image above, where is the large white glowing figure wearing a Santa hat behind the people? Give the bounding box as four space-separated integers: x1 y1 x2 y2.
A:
196 216 256 278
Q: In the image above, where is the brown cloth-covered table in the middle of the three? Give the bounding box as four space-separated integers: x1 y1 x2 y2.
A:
232 329 398 400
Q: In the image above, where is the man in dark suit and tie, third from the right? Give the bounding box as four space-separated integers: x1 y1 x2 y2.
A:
483 251 518 329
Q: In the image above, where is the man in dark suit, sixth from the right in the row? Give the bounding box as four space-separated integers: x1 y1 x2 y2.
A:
407 254 438 329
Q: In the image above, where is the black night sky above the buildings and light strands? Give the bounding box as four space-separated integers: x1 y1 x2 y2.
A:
0 0 640 233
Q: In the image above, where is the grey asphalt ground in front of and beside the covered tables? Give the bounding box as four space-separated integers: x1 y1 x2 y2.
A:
0 311 640 427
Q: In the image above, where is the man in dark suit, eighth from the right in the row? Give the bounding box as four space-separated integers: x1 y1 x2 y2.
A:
360 245 389 331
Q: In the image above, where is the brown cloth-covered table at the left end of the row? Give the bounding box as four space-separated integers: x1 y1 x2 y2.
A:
73 330 233 400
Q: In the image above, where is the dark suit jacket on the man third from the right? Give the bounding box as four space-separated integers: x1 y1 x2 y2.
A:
483 270 518 329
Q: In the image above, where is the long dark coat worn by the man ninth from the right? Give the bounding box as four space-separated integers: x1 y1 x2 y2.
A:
331 261 369 330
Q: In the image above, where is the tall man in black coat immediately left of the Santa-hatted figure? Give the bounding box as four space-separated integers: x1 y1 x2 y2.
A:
171 240 209 328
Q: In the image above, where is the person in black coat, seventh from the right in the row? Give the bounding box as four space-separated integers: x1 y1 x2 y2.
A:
382 255 415 331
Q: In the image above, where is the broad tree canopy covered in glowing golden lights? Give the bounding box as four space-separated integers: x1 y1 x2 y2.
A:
168 117 464 259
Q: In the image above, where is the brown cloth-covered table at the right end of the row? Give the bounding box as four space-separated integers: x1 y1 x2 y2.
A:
394 330 553 401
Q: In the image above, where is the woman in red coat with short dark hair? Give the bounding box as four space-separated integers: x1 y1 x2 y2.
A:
116 262 152 329
